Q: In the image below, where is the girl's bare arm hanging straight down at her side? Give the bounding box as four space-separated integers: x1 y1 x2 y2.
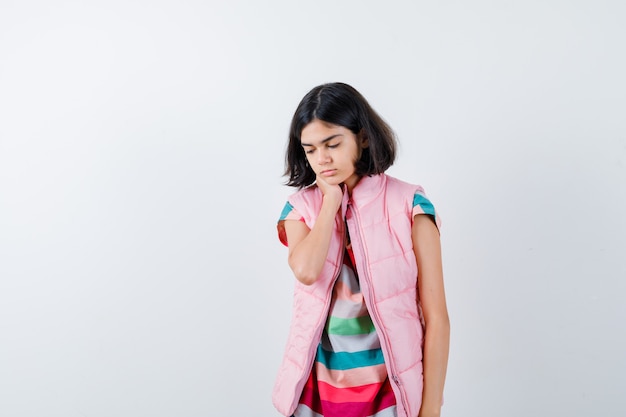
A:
412 214 450 417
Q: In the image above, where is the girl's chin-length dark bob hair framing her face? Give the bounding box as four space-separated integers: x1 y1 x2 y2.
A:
285 83 396 188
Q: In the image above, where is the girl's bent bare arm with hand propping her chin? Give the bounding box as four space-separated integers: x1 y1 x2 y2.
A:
285 178 343 285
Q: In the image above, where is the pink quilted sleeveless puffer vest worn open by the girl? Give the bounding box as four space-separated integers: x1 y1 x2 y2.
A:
272 174 423 417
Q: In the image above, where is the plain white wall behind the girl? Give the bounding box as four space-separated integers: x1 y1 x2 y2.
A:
0 0 626 417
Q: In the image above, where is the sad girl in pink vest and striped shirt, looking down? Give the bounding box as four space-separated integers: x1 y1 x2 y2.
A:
273 83 450 417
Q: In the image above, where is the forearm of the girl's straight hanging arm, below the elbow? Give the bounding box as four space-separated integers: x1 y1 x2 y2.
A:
419 315 450 417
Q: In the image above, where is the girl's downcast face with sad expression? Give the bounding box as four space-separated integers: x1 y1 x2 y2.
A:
300 119 367 190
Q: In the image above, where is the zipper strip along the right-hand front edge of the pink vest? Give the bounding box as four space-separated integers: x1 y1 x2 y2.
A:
348 203 409 416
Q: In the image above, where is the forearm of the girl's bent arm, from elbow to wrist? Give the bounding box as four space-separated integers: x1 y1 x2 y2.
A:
289 198 338 285
